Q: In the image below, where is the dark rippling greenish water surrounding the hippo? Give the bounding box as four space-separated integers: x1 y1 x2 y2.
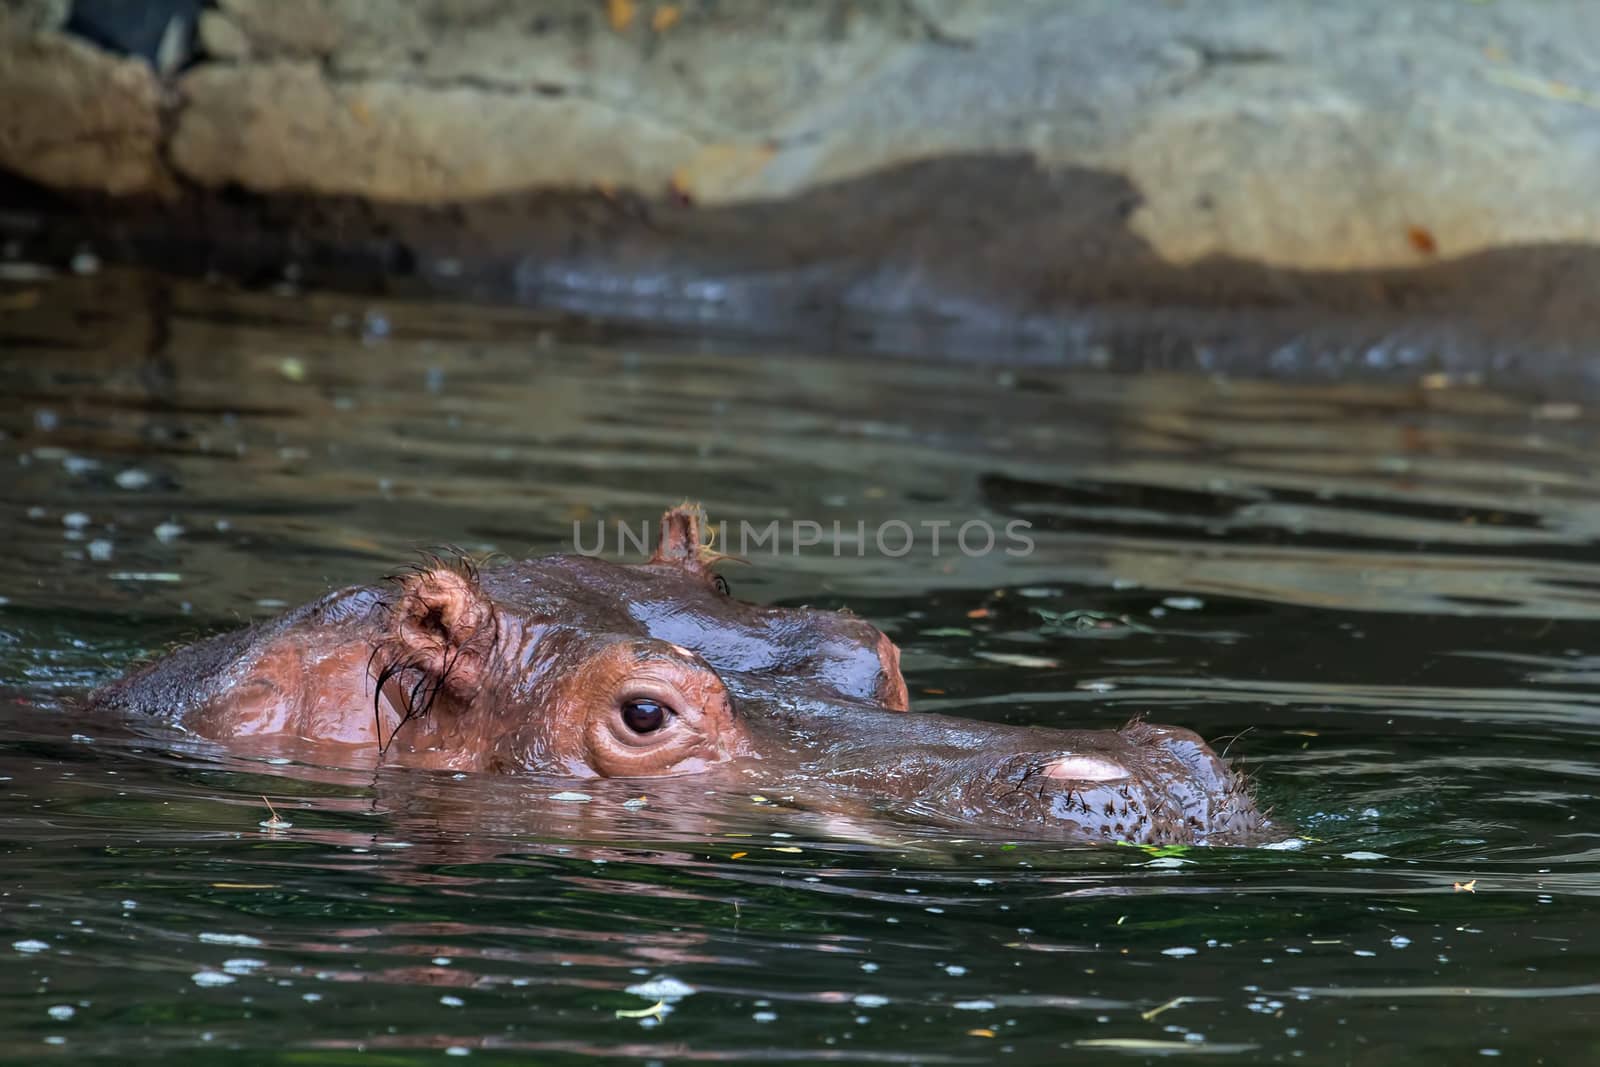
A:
0 275 1600 1065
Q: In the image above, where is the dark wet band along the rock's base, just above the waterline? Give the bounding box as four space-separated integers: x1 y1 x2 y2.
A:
0 155 1600 390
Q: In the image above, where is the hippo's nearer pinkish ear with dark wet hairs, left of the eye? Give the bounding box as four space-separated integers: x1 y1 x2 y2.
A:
394 565 498 697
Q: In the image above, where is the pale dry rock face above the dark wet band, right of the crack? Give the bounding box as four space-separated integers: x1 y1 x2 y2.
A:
165 0 1600 269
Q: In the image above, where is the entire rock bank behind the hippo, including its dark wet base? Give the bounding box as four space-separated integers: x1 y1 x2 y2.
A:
0 0 1600 355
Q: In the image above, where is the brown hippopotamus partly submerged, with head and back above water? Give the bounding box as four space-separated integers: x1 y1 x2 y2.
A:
90 506 1267 843
